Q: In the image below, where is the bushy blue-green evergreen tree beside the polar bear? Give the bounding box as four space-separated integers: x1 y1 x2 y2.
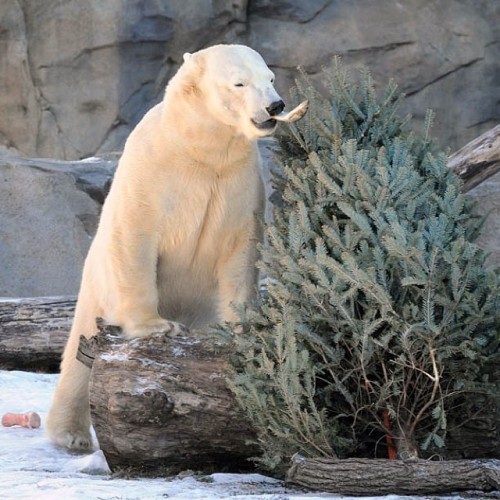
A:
217 59 500 468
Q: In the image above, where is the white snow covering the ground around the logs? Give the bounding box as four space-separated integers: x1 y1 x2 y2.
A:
0 370 470 500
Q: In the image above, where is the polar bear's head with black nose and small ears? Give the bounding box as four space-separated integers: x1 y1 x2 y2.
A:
181 45 285 139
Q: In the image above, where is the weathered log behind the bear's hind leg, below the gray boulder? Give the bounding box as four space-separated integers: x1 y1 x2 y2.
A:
0 297 76 372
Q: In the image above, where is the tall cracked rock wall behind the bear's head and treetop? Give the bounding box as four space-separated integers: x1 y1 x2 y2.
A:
0 0 500 159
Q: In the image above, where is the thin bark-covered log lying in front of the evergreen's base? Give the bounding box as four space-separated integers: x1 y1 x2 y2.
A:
287 455 500 496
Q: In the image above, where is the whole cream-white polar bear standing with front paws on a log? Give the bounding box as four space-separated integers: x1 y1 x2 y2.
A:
46 45 285 449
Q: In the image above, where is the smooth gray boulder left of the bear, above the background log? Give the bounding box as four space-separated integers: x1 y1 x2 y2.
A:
0 156 116 297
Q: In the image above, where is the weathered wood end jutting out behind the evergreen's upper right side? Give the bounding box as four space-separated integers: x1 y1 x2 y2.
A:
448 125 500 192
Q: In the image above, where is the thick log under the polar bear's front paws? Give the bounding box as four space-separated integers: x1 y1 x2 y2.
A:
79 325 258 472
